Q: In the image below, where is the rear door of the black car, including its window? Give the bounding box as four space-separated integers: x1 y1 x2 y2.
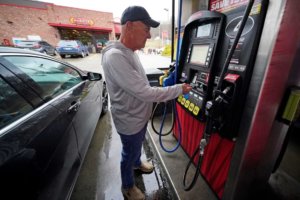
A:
0 65 41 199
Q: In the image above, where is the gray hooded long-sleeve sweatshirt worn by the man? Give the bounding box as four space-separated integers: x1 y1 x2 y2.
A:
102 41 182 135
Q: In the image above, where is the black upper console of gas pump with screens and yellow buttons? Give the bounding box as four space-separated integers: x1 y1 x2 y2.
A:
177 11 224 122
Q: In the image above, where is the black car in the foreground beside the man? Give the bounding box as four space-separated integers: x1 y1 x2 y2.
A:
0 47 108 200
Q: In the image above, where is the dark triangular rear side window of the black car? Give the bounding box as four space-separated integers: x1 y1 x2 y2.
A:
0 77 33 129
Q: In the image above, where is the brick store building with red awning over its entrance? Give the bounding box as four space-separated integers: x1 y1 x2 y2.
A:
0 0 120 50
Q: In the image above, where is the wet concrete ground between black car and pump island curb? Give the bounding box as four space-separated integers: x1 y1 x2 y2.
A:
71 112 177 200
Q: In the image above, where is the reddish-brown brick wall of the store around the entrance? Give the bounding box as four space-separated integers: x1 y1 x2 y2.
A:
0 4 114 46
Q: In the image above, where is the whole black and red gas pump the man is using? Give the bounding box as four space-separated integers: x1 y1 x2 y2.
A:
174 0 268 198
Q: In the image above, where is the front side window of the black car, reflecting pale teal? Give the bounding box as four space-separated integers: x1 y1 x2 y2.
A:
4 56 82 100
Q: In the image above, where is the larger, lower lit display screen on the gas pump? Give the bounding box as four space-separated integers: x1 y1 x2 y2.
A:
190 45 209 65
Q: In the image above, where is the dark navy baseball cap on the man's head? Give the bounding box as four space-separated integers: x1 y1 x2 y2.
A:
121 6 159 28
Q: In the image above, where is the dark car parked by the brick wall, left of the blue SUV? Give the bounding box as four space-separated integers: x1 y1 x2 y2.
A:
16 40 57 56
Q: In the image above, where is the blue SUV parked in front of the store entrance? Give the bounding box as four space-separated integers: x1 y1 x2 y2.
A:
56 40 89 58
